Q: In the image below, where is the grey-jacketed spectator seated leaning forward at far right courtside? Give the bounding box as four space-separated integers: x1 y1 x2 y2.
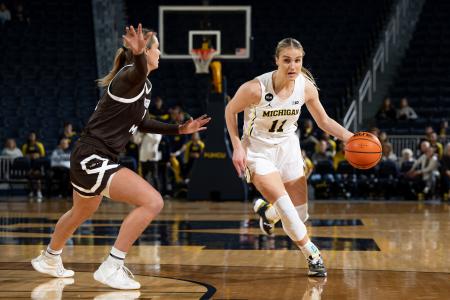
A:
407 147 439 195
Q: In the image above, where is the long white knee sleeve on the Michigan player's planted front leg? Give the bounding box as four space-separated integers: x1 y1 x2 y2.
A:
273 194 307 242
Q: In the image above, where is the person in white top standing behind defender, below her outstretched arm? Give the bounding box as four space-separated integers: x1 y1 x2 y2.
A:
134 132 162 191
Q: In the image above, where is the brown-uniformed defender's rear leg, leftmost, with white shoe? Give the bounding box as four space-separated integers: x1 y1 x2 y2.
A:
31 191 102 277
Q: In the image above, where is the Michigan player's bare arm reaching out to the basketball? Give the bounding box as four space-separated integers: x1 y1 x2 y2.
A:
305 79 353 143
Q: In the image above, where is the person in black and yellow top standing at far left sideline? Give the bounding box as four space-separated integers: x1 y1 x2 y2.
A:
22 131 45 202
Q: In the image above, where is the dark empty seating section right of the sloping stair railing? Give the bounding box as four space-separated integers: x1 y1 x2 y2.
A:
378 0 450 134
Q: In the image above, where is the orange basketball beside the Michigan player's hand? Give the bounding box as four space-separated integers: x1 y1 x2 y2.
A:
345 132 382 169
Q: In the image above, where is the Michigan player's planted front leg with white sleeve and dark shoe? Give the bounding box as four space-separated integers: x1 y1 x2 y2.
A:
252 172 327 277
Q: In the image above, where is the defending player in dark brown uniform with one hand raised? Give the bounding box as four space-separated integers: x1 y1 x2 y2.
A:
31 24 210 289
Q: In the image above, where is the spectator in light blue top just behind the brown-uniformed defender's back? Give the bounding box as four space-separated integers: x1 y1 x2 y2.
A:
50 138 72 197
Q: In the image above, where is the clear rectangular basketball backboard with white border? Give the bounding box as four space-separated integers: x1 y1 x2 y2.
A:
159 6 251 60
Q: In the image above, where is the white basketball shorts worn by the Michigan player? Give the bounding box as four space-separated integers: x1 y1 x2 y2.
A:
242 135 305 182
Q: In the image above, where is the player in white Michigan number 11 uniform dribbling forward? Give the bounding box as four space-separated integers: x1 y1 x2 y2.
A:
225 38 353 277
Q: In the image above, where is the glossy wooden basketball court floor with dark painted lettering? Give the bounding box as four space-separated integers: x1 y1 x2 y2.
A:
0 199 450 300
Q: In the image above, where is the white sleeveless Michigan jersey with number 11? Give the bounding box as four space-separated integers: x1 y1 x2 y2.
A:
244 71 305 144
